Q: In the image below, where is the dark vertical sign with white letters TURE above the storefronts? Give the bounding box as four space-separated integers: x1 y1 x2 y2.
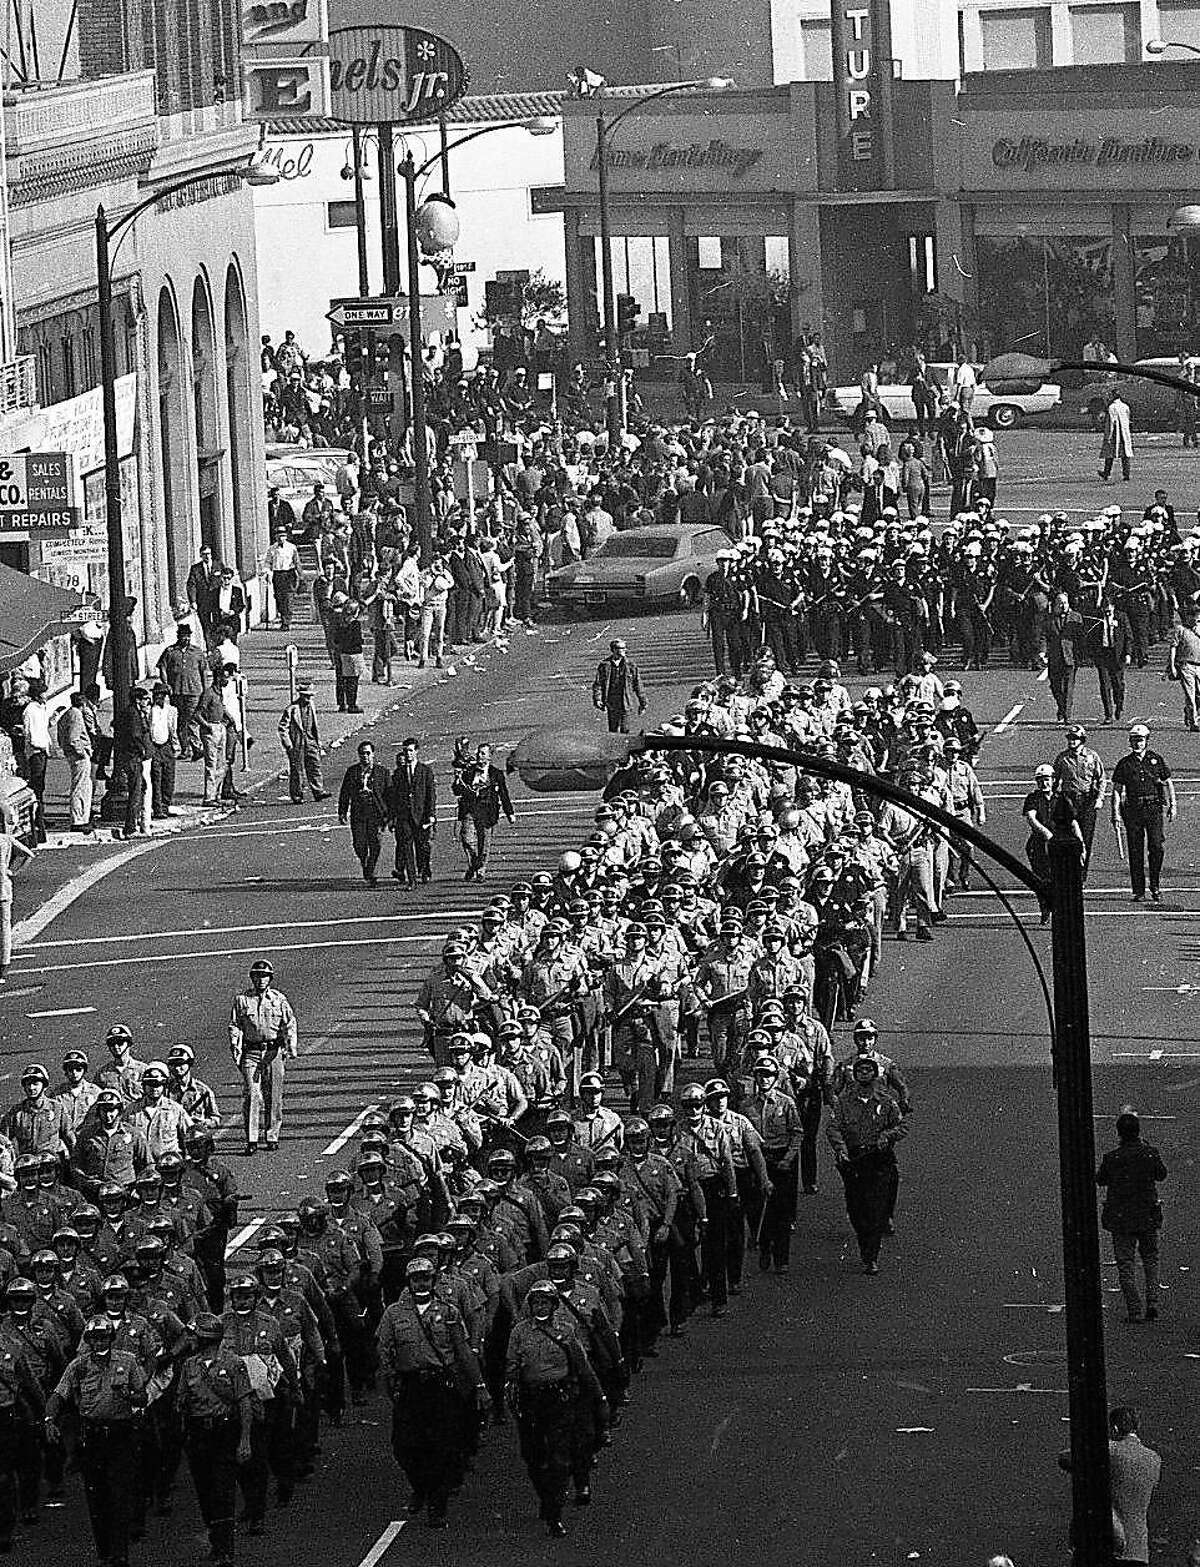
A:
832 0 893 191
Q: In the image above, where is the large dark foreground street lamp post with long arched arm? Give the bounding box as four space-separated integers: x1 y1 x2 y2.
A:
508 729 1112 1567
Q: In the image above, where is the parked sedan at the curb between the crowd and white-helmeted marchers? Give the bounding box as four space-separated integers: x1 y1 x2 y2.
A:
547 523 730 611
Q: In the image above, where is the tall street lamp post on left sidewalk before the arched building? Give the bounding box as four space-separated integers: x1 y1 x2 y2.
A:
96 157 279 749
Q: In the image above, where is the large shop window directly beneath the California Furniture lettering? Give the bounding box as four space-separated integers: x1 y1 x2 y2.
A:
976 235 1115 359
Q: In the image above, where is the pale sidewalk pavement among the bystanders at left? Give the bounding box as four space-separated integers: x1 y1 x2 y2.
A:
42 605 440 852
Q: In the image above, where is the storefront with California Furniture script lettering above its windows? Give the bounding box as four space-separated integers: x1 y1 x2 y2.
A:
946 64 1200 362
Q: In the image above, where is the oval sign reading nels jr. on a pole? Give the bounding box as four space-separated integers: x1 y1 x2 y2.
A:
329 22 467 125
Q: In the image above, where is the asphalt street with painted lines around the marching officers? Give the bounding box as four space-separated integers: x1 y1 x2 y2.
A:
0 470 1200 1567
